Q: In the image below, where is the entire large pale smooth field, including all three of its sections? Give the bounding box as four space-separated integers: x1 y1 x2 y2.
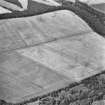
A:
0 2 105 102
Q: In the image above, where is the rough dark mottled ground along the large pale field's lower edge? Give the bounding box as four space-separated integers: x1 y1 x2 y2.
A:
17 71 105 105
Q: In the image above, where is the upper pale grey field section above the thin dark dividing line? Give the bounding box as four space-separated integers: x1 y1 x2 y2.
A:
0 11 91 53
